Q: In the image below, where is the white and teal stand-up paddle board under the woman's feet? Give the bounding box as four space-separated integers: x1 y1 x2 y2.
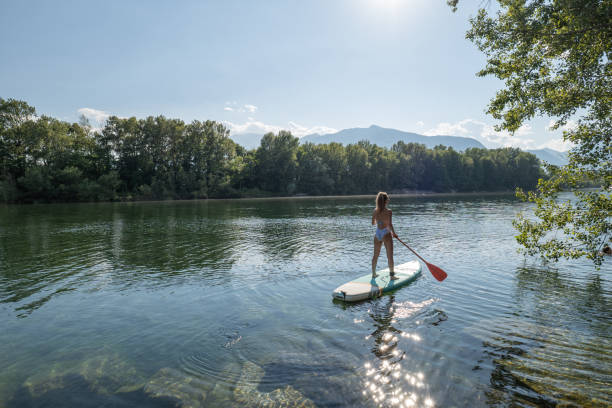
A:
332 261 421 302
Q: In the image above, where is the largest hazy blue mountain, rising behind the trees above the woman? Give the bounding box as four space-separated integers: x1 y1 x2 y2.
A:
300 125 485 151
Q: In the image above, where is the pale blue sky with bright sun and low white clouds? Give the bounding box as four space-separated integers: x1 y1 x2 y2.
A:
0 0 571 150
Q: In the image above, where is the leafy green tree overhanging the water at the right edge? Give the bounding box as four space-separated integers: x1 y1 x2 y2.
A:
448 0 612 265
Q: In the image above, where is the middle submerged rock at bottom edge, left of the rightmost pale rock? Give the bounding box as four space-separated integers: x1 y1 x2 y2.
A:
144 367 211 408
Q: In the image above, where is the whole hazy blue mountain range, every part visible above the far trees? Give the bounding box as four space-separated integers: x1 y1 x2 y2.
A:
231 125 567 165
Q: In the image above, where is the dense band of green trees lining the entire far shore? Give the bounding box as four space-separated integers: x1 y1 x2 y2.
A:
0 98 545 203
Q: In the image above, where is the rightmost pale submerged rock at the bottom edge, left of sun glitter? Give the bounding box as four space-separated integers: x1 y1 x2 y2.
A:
234 362 315 408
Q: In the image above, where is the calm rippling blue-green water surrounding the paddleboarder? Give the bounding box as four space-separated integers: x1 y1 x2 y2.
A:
0 196 612 407
